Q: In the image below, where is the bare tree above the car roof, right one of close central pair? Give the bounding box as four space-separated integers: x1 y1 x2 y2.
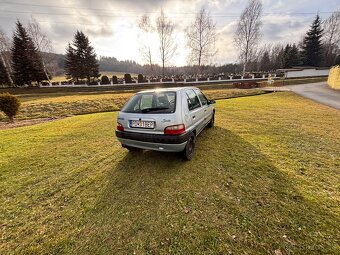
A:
156 10 177 77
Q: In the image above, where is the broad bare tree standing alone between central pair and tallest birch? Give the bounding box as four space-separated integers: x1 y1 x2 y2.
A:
186 8 216 72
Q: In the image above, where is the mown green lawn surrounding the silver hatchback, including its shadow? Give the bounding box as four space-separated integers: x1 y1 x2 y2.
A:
0 92 340 254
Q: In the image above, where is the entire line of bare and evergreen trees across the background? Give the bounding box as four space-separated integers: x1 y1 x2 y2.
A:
0 0 340 86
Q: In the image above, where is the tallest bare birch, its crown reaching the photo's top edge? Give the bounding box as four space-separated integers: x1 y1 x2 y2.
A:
234 0 262 75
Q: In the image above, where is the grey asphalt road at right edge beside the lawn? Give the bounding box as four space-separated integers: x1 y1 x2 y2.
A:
286 82 340 109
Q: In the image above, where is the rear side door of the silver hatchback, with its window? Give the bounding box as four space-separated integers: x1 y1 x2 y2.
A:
186 89 204 134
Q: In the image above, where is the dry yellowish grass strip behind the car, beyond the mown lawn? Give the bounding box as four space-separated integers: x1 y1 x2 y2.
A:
0 89 264 120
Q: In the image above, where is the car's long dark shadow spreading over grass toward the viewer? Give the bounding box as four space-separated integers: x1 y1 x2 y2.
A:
70 126 339 254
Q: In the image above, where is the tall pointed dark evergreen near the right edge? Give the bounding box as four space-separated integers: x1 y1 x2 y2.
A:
302 15 323 66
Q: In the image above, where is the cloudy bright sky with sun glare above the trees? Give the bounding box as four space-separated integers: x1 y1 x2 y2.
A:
0 0 340 66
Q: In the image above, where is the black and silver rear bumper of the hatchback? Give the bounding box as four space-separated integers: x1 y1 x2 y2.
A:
116 130 190 152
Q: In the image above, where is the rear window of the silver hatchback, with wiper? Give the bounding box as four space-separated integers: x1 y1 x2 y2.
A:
122 91 176 114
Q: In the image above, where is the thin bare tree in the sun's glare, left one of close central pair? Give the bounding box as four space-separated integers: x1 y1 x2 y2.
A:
138 15 155 73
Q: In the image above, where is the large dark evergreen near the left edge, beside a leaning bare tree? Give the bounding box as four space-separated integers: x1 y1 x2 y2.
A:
11 21 47 85
